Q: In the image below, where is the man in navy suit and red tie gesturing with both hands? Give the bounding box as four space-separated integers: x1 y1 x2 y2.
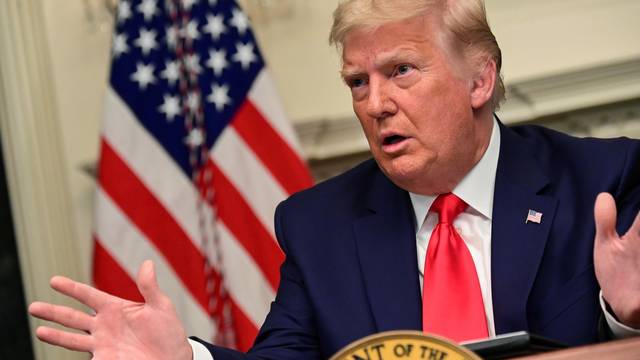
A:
30 0 640 360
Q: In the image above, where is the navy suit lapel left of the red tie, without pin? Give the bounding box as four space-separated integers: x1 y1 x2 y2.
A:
353 173 422 331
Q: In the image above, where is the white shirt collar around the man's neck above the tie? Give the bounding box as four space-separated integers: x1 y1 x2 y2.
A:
409 117 500 228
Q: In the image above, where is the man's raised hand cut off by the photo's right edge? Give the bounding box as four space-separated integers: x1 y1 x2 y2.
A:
594 194 640 328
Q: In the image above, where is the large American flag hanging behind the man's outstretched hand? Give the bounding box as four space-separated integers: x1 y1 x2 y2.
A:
93 0 312 350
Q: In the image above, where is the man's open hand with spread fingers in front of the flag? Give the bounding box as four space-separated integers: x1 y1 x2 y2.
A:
29 261 192 360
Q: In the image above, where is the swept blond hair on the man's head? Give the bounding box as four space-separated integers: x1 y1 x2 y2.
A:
329 0 505 110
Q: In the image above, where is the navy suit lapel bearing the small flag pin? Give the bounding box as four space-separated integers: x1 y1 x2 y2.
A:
491 125 557 334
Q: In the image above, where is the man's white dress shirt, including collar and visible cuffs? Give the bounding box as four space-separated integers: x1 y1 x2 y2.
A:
189 119 640 360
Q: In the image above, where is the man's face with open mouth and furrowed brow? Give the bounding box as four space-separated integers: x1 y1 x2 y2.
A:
342 15 492 195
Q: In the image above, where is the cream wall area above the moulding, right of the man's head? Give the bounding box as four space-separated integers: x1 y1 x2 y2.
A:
486 0 640 82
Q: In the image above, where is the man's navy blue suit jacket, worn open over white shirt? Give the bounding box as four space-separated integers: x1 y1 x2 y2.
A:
200 125 640 360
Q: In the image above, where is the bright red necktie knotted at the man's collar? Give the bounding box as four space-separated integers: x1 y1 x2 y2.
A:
422 193 489 342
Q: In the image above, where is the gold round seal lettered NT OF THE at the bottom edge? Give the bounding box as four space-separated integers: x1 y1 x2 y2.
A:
330 331 480 360
